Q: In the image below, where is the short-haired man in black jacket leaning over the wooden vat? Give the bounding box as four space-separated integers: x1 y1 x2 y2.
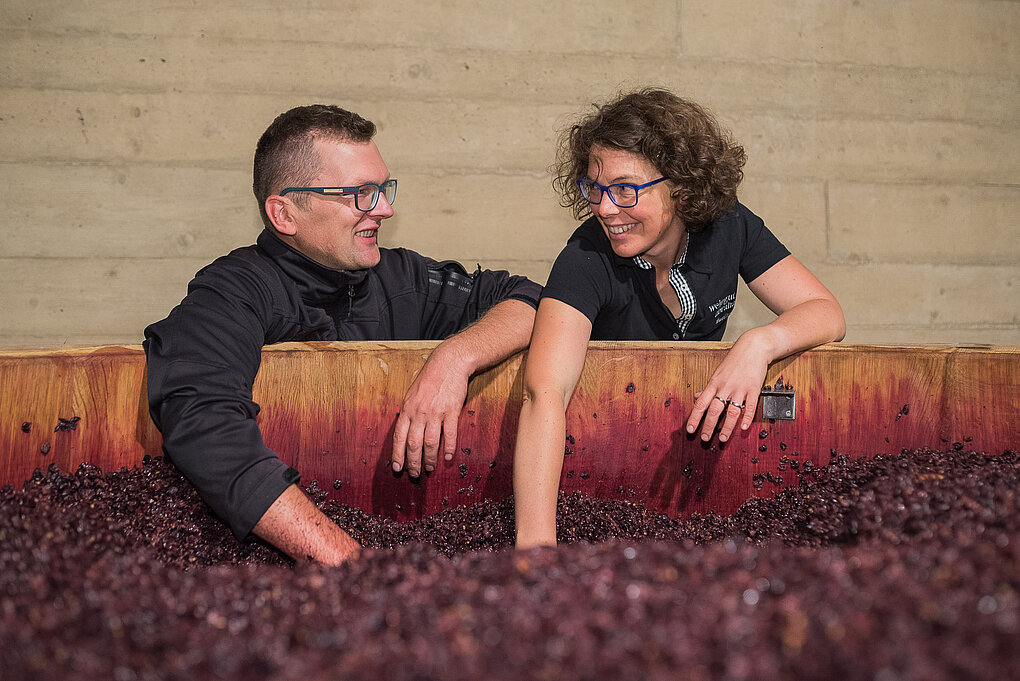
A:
144 105 540 565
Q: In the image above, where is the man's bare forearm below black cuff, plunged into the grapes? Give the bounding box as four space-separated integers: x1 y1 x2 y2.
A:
253 485 361 565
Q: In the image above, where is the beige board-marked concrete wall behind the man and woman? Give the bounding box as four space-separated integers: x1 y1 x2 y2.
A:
0 0 1020 347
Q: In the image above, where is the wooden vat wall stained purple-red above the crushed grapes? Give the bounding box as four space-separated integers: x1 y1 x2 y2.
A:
0 342 1020 520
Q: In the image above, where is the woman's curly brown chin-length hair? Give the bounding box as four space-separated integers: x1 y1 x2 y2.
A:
553 88 747 231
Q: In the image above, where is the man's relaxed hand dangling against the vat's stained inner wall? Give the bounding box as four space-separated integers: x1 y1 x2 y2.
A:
393 343 471 477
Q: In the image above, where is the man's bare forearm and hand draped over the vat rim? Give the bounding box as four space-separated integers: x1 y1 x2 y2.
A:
393 300 534 476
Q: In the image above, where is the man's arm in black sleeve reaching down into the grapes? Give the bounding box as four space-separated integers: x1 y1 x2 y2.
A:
144 261 357 564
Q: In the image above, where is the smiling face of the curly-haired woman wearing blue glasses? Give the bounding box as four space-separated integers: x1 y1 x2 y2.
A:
588 145 683 267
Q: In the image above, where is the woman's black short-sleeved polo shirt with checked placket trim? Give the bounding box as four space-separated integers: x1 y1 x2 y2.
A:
542 203 789 341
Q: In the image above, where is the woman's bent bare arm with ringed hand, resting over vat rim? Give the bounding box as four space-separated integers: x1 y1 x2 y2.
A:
687 256 847 442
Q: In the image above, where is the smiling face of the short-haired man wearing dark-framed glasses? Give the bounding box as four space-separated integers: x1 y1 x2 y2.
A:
290 140 393 270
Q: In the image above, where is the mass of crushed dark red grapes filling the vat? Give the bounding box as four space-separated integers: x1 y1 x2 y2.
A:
0 451 1020 681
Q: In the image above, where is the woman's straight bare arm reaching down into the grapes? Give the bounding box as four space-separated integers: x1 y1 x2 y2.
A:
513 298 592 548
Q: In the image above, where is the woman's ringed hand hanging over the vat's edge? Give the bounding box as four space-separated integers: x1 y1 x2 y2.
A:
687 328 772 442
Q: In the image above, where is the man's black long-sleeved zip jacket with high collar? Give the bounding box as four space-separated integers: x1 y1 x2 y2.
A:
144 230 541 538
